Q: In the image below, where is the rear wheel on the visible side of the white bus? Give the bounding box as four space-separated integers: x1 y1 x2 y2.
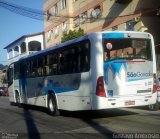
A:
48 95 60 116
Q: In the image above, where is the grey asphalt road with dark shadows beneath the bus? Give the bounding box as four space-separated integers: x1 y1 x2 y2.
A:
0 96 160 139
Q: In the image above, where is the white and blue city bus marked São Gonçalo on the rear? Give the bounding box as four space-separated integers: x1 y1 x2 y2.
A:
7 31 157 115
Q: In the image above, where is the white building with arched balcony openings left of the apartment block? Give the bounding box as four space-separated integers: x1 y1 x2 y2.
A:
4 32 45 64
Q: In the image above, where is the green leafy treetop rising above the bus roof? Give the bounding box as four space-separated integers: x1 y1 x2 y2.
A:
61 28 85 42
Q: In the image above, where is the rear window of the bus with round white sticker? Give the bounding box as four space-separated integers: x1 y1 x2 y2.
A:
103 38 152 61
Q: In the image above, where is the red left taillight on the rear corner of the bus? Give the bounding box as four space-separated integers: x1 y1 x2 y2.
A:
96 76 106 97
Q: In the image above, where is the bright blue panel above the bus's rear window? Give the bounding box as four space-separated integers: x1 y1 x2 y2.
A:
102 33 125 39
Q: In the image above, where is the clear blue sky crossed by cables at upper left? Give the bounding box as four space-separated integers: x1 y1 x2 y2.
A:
0 0 44 65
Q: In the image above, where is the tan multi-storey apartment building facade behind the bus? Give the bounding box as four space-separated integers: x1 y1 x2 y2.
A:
44 0 160 47
